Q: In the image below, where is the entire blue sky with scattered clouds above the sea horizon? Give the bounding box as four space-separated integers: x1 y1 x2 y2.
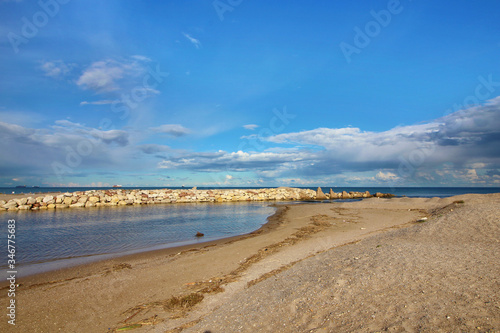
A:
0 0 500 187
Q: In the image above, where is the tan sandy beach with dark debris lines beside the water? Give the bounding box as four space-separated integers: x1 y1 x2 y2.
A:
0 194 500 333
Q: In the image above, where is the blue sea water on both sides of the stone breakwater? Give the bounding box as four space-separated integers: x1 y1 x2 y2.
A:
0 186 500 277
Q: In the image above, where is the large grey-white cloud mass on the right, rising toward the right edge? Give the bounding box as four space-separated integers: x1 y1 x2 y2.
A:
154 95 500 184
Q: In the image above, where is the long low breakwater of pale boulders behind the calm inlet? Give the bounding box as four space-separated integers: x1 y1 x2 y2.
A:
0 187 393 211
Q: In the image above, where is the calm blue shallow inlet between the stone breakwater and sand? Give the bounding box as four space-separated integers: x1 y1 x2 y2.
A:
0 202 276 271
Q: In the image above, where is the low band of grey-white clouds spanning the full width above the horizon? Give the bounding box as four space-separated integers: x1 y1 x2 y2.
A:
0 96 500 186
